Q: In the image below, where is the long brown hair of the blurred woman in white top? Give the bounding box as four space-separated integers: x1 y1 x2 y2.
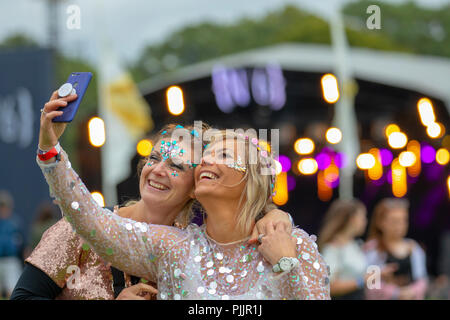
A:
317 199 366 249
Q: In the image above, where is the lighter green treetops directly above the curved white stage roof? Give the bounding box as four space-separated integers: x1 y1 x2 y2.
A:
132 5 411 81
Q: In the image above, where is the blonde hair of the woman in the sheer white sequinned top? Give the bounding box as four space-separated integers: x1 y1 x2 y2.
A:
210 130 277 234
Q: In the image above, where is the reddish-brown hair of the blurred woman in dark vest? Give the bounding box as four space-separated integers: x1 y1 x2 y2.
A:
367 198 409 251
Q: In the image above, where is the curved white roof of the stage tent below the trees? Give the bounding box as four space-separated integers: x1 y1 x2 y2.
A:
140 44 450 113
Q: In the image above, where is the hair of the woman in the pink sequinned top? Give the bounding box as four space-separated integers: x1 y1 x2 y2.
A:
124 122 210 227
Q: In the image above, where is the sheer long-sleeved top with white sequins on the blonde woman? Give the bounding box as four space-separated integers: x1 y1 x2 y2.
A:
37 151 330 300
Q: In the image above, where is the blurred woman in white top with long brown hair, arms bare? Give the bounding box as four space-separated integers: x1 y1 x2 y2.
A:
318 200 367 300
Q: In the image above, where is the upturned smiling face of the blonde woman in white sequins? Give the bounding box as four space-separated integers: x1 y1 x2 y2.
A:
194 138 246 202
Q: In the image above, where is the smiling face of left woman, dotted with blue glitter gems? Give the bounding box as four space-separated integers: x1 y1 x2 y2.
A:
139 140 194 209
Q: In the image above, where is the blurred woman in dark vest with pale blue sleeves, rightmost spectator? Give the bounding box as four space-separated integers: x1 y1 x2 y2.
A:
364 198 428 300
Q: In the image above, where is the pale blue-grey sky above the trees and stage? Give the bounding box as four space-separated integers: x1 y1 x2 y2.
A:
0 0 450 62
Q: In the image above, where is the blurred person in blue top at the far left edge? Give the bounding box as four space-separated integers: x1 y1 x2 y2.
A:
0 190 24 297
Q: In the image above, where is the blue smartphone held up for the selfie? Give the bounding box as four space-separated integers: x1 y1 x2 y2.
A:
53 72 92 122
